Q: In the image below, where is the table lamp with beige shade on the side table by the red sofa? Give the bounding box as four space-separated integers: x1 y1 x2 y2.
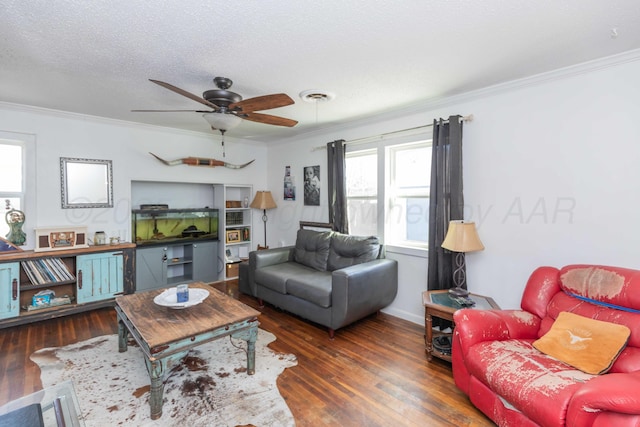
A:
442 220 484 297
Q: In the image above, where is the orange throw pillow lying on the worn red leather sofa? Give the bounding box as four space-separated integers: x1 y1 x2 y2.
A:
533 311 631 375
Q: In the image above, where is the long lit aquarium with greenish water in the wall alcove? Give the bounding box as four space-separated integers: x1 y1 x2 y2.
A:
131 207 218 245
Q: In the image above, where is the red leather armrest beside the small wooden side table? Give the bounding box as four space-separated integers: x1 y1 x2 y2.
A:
453 308 540 354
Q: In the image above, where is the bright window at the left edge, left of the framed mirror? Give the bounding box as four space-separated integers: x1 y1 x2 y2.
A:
0 139 25 238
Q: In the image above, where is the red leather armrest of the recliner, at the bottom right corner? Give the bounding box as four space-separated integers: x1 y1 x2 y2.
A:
567 371 640 426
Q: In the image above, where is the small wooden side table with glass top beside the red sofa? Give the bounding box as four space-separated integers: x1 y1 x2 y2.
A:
422 290 500 362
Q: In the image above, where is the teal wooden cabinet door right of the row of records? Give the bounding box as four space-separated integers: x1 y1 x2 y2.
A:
76 251 124 304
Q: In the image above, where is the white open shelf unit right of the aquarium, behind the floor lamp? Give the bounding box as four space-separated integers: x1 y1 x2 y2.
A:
214 184 254 280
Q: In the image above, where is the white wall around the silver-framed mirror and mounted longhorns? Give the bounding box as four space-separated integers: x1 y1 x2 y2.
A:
0 104 266 249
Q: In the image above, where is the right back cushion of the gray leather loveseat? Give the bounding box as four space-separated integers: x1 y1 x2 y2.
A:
327 233 380 271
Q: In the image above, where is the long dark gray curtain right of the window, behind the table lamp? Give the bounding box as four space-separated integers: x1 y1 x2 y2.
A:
427 116 466 290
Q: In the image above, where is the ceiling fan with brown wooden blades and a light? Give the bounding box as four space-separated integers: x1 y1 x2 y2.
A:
131 77 298 155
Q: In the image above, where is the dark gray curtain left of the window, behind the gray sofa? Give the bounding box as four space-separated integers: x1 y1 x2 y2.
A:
327 139 349 234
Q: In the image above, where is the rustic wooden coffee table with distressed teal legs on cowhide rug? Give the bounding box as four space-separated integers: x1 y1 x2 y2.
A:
115 282 260 420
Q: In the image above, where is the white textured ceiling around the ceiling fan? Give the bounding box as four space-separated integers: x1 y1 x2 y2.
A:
0 0 640 141
